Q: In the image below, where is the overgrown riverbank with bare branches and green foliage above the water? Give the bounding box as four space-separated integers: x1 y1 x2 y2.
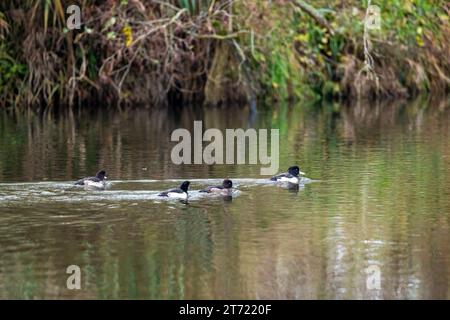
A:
0 0 450 107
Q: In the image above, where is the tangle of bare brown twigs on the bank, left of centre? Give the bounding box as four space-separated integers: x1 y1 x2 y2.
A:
70 0 250 103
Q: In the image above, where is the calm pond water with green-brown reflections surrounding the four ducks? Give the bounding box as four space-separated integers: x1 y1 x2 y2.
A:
0 101 450 299
